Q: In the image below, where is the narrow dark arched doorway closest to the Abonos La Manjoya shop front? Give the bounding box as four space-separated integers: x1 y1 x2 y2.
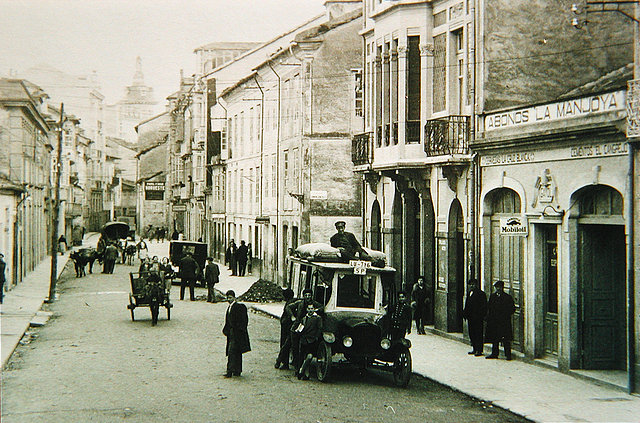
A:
447 198 465 332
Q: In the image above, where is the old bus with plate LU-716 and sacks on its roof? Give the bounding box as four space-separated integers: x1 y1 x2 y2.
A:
288 245 412 387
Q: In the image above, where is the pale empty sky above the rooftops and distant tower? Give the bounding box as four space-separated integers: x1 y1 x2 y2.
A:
0 0 324 104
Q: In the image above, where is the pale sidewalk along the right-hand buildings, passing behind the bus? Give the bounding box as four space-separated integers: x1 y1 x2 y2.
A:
251 303 640 422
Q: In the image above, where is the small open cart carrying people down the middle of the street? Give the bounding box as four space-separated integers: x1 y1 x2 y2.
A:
127 270 173 326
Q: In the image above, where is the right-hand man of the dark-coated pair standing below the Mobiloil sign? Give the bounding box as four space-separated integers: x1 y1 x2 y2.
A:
485 281 516 360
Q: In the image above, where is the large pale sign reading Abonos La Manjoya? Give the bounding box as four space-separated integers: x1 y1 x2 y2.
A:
484 91 626 132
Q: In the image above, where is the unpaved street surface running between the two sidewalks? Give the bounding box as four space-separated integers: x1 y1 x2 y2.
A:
2 250 526 423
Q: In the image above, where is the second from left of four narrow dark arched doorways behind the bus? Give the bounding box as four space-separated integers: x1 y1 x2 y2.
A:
403 189 420 292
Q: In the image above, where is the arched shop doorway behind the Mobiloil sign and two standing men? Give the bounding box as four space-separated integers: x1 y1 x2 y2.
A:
485 188 525 352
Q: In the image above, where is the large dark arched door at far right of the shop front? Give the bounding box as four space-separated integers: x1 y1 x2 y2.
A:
577 185 626 370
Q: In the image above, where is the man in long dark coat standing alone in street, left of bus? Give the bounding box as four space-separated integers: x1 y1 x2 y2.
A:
222 290 251 377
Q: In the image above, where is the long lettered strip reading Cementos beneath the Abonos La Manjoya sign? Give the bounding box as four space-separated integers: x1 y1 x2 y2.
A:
480 142 629 166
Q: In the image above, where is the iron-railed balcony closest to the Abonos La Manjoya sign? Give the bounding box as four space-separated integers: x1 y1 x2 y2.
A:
424 115 469 157
